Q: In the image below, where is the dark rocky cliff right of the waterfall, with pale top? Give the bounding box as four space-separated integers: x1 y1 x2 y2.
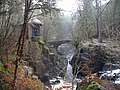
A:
70 41 120 78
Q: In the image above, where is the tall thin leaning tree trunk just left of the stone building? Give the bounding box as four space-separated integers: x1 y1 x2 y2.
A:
12 0 32 90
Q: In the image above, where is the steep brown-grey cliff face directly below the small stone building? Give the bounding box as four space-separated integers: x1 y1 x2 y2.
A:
25 40 67 78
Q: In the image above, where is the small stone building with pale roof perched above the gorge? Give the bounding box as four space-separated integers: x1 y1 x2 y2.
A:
15 18 43 40
